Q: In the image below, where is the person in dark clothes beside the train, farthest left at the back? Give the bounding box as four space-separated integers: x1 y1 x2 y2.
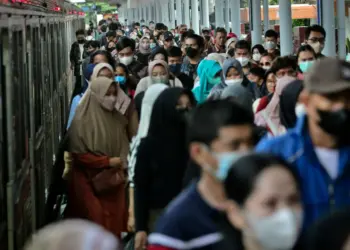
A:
69 29 86 98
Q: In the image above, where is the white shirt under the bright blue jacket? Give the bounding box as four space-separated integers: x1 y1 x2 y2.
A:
315 147 339 180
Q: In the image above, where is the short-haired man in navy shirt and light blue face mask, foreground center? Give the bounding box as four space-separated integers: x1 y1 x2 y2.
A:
148 100 253 250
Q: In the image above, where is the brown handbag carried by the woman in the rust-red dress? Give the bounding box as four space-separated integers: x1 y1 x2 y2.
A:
91 167 126 195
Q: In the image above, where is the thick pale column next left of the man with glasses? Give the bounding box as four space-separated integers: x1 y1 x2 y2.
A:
279 0 293 56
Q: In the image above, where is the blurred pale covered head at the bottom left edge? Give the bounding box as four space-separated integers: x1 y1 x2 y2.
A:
24 219 120 250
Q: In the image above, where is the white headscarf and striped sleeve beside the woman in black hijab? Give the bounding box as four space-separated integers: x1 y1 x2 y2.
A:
128 83 168 187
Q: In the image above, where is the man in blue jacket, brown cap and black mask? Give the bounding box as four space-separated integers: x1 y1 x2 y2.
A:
257 58 350 228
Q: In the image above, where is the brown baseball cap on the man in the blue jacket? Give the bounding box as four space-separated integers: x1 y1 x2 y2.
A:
304 58 350 94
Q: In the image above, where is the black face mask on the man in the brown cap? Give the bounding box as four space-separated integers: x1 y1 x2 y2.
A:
317 109 350 144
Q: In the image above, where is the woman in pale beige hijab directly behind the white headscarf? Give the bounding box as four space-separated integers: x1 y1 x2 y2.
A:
135 60 182 95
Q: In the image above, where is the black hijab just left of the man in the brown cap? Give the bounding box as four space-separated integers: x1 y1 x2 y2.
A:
280 80 303 129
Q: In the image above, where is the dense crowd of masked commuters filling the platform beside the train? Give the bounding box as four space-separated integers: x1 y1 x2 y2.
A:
26 17 350 250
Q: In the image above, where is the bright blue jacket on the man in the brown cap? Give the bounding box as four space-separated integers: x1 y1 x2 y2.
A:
256 116 350 227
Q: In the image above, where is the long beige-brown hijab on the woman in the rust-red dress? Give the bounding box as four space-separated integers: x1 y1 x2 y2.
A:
68 77 129 159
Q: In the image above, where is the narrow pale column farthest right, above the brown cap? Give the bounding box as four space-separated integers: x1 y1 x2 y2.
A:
337 0 346 59
